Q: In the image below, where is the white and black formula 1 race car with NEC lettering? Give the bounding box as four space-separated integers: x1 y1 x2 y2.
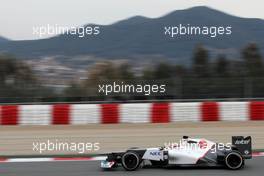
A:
101 136 252 171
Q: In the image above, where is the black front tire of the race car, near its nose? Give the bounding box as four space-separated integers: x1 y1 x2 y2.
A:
122 152 141 171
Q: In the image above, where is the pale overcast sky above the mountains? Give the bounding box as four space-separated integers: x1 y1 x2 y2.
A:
0 0 264 40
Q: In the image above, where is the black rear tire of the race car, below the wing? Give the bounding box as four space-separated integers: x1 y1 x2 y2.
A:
225 151 245 170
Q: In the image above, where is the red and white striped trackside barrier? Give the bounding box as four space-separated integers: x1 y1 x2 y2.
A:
0 101 264 125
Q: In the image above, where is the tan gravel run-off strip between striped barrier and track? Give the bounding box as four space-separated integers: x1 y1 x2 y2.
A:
0 121 264 155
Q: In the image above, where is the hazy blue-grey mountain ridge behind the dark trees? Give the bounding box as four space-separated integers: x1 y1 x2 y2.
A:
0 6 264 63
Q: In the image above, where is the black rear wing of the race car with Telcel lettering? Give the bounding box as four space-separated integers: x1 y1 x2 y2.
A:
232 136 252 159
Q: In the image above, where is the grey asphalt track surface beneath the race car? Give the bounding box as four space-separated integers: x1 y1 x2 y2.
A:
0 157 264 176
